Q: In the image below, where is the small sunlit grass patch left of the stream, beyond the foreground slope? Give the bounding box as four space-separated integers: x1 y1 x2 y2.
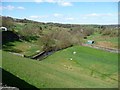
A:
3 41 42 56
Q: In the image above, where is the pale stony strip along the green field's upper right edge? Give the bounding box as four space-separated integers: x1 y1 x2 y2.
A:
82 44 120 53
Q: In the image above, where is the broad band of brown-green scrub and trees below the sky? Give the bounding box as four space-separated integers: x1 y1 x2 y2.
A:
2 17 119 51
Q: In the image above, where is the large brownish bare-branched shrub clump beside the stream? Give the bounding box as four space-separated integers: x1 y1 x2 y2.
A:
42 29 81 51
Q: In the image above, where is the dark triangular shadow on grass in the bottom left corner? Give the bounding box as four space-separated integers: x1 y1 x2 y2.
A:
0 68 39 90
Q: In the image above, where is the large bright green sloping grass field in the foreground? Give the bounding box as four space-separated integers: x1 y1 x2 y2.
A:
2 46 118 88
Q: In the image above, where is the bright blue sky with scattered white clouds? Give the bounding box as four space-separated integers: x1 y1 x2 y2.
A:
0 0 118 24
